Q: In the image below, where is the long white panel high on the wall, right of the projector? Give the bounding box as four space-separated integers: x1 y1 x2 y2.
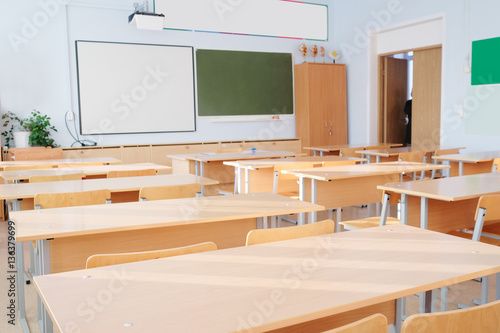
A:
155 0 328 40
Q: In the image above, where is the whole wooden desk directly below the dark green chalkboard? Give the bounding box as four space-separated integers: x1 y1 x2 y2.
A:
168 150 300 191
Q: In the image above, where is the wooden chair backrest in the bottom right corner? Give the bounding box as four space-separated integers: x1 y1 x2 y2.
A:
401 301 500 333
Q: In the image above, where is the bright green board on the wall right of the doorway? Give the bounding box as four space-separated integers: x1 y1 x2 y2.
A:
472 38 500 85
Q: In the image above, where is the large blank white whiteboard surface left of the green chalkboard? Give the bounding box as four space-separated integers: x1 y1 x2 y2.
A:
76 41 196 135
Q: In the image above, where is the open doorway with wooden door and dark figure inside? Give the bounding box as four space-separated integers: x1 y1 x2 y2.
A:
378 46 442 149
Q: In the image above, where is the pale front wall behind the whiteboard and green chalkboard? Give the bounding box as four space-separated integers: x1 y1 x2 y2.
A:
0 0 333 146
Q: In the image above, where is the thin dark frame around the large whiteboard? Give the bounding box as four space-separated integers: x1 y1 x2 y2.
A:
75 39 198 136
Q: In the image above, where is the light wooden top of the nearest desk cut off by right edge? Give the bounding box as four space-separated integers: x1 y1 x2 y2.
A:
378 173 500 201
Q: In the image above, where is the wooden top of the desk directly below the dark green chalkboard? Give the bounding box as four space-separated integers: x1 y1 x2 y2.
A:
168 150 300 162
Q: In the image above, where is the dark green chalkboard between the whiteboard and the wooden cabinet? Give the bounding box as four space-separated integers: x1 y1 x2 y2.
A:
196 50 293 116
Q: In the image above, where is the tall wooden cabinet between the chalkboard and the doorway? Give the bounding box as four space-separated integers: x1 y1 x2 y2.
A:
295 63 347 147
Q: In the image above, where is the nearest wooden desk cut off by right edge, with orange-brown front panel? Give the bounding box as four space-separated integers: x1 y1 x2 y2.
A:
378 173 500 232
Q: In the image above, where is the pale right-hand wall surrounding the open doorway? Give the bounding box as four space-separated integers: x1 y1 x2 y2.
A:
333 0 500 150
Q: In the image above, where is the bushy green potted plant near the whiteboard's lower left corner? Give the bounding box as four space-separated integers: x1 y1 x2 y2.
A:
22 110 57 147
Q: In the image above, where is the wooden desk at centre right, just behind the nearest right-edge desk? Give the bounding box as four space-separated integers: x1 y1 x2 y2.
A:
283 162 448 224
